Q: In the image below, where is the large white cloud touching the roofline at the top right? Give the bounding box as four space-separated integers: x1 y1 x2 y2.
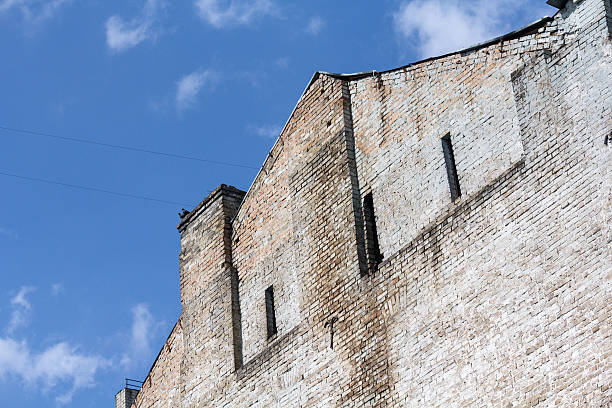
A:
393 0 546 57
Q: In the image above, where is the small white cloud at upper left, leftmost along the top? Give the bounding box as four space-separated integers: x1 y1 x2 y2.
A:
106 0 166 52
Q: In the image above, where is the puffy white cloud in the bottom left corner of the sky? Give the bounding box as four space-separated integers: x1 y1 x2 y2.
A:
0 338 110 404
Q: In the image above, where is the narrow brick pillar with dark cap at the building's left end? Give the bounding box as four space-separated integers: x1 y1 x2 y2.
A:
179 185 244 406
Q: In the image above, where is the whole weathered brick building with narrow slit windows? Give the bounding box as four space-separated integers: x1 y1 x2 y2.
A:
117 0 612 408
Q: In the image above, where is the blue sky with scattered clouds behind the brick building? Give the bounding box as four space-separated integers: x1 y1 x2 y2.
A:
0 0 555 408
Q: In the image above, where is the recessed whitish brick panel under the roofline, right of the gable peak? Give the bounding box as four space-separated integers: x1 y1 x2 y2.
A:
351 0 605 262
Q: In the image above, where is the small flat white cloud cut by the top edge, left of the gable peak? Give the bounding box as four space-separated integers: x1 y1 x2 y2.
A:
195 0 278 28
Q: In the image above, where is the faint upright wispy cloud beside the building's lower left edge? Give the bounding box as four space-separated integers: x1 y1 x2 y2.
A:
121 303 164 366
